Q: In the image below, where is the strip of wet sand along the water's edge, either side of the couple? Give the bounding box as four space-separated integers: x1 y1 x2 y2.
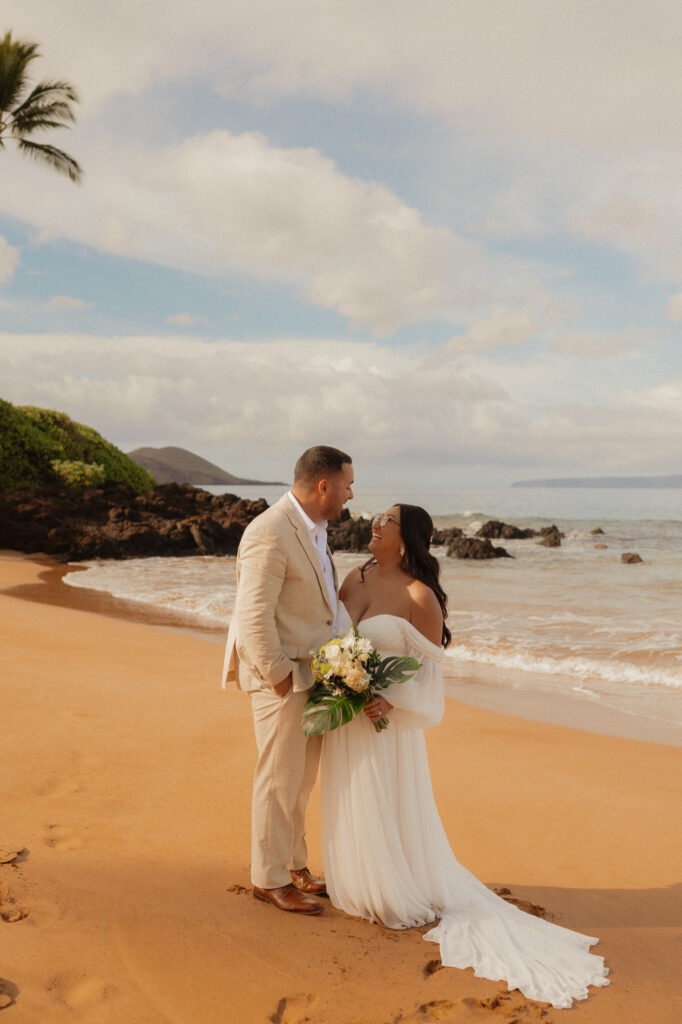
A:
6 551 682 746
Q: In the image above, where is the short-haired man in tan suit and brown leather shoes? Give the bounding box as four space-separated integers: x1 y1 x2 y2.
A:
223 444 353 914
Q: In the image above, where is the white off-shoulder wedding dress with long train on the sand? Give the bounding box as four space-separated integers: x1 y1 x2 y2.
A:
322 614 608 1009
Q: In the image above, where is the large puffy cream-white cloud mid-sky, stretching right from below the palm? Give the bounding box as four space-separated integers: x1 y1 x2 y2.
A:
0 131 495 336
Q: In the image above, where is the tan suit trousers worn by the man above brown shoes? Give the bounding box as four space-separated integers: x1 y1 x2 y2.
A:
250 689 322 889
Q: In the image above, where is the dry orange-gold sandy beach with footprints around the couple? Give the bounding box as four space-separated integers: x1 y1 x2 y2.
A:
0 552 682 1024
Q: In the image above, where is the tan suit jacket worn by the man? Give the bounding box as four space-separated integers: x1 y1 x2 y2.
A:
222 495 336 691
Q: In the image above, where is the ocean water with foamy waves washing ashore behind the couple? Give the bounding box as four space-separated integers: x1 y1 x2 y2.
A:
65 487 682 738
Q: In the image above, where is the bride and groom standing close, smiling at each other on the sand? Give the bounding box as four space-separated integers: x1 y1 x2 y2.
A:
223 445 608 1008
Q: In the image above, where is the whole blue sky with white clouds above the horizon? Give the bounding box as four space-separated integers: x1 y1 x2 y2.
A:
0 0 682 486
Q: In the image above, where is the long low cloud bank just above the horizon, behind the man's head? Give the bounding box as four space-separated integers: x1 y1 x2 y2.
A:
0 334 682 480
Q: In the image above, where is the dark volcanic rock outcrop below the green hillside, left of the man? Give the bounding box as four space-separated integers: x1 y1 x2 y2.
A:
0 483 267 561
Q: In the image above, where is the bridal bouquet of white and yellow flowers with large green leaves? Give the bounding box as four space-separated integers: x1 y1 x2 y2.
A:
302 626 420 736
